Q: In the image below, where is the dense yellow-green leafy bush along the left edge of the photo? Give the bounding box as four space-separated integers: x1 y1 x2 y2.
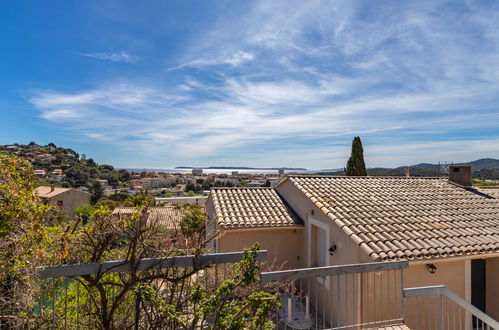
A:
0 153 51 328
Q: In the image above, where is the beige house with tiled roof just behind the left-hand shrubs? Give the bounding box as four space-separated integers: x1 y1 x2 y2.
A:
35 186 90 215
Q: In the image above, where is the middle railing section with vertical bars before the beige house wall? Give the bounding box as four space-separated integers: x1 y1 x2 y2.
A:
260 261 408 329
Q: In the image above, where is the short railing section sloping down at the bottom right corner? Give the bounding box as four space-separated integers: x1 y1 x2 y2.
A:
404 285 499 330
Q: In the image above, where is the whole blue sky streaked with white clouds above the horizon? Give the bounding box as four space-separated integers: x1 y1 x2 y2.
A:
0 0 499 169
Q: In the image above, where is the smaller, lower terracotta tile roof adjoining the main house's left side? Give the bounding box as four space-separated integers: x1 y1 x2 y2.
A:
210 188 303 229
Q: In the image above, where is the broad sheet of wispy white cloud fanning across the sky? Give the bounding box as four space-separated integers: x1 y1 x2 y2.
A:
31 1 499 168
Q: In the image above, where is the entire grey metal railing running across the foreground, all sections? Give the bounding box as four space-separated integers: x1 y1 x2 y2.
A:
31 251 499 330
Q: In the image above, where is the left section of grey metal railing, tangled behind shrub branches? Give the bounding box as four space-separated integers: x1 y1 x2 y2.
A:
35 250 267 329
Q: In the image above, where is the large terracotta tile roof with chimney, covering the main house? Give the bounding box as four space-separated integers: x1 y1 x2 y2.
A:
289 177 499 260
